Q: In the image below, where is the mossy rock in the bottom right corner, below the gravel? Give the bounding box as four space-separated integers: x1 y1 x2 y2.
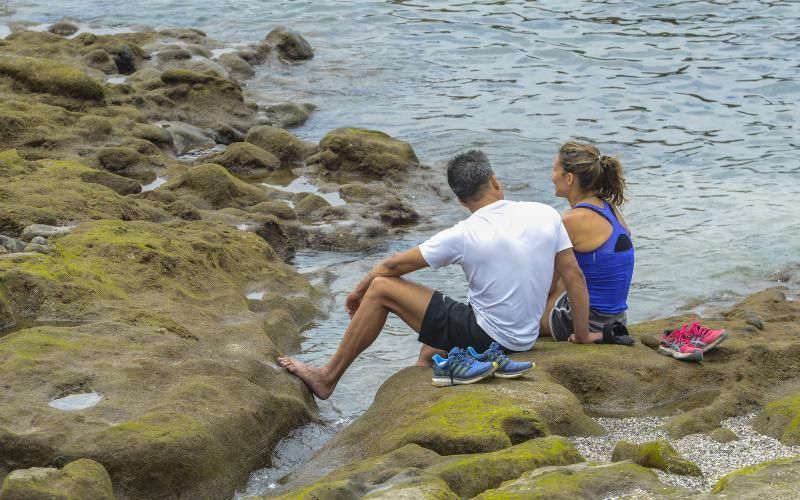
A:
711 456 800 500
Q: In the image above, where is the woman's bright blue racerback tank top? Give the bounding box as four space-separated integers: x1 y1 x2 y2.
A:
575 201 634 314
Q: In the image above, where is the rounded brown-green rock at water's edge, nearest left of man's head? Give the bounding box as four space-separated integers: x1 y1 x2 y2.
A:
308 128 419 178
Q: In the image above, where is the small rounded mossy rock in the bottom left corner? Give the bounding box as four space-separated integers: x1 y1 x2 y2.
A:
0 458 114 500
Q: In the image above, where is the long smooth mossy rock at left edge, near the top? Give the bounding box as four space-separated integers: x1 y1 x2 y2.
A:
0 56 105 100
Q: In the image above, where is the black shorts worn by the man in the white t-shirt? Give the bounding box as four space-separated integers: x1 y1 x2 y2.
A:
418 291 494 352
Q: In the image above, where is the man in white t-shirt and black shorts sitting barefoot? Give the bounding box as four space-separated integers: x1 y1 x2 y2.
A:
278 150 597 399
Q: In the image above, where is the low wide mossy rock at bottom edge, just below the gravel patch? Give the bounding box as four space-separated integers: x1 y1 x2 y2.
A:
476 462 688 500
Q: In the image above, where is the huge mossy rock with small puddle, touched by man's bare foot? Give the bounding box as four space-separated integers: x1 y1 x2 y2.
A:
0 221 316 498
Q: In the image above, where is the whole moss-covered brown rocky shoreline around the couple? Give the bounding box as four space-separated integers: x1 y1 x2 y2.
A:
0 20 800 499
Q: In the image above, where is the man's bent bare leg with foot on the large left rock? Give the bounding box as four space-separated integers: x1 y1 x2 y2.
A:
278 277 433 399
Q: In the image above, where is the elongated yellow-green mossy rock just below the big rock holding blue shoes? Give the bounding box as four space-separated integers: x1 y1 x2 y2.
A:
427 436 584 498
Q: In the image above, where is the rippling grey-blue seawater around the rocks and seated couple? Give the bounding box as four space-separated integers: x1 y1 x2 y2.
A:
0 0 800 492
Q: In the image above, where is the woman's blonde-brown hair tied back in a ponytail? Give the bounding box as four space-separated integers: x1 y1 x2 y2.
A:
558 142 626 206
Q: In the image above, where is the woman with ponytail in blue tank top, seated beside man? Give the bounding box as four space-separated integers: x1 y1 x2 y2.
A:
540 142 634 340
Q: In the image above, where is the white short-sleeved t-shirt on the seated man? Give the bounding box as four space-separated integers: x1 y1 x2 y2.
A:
419 200 572 351
